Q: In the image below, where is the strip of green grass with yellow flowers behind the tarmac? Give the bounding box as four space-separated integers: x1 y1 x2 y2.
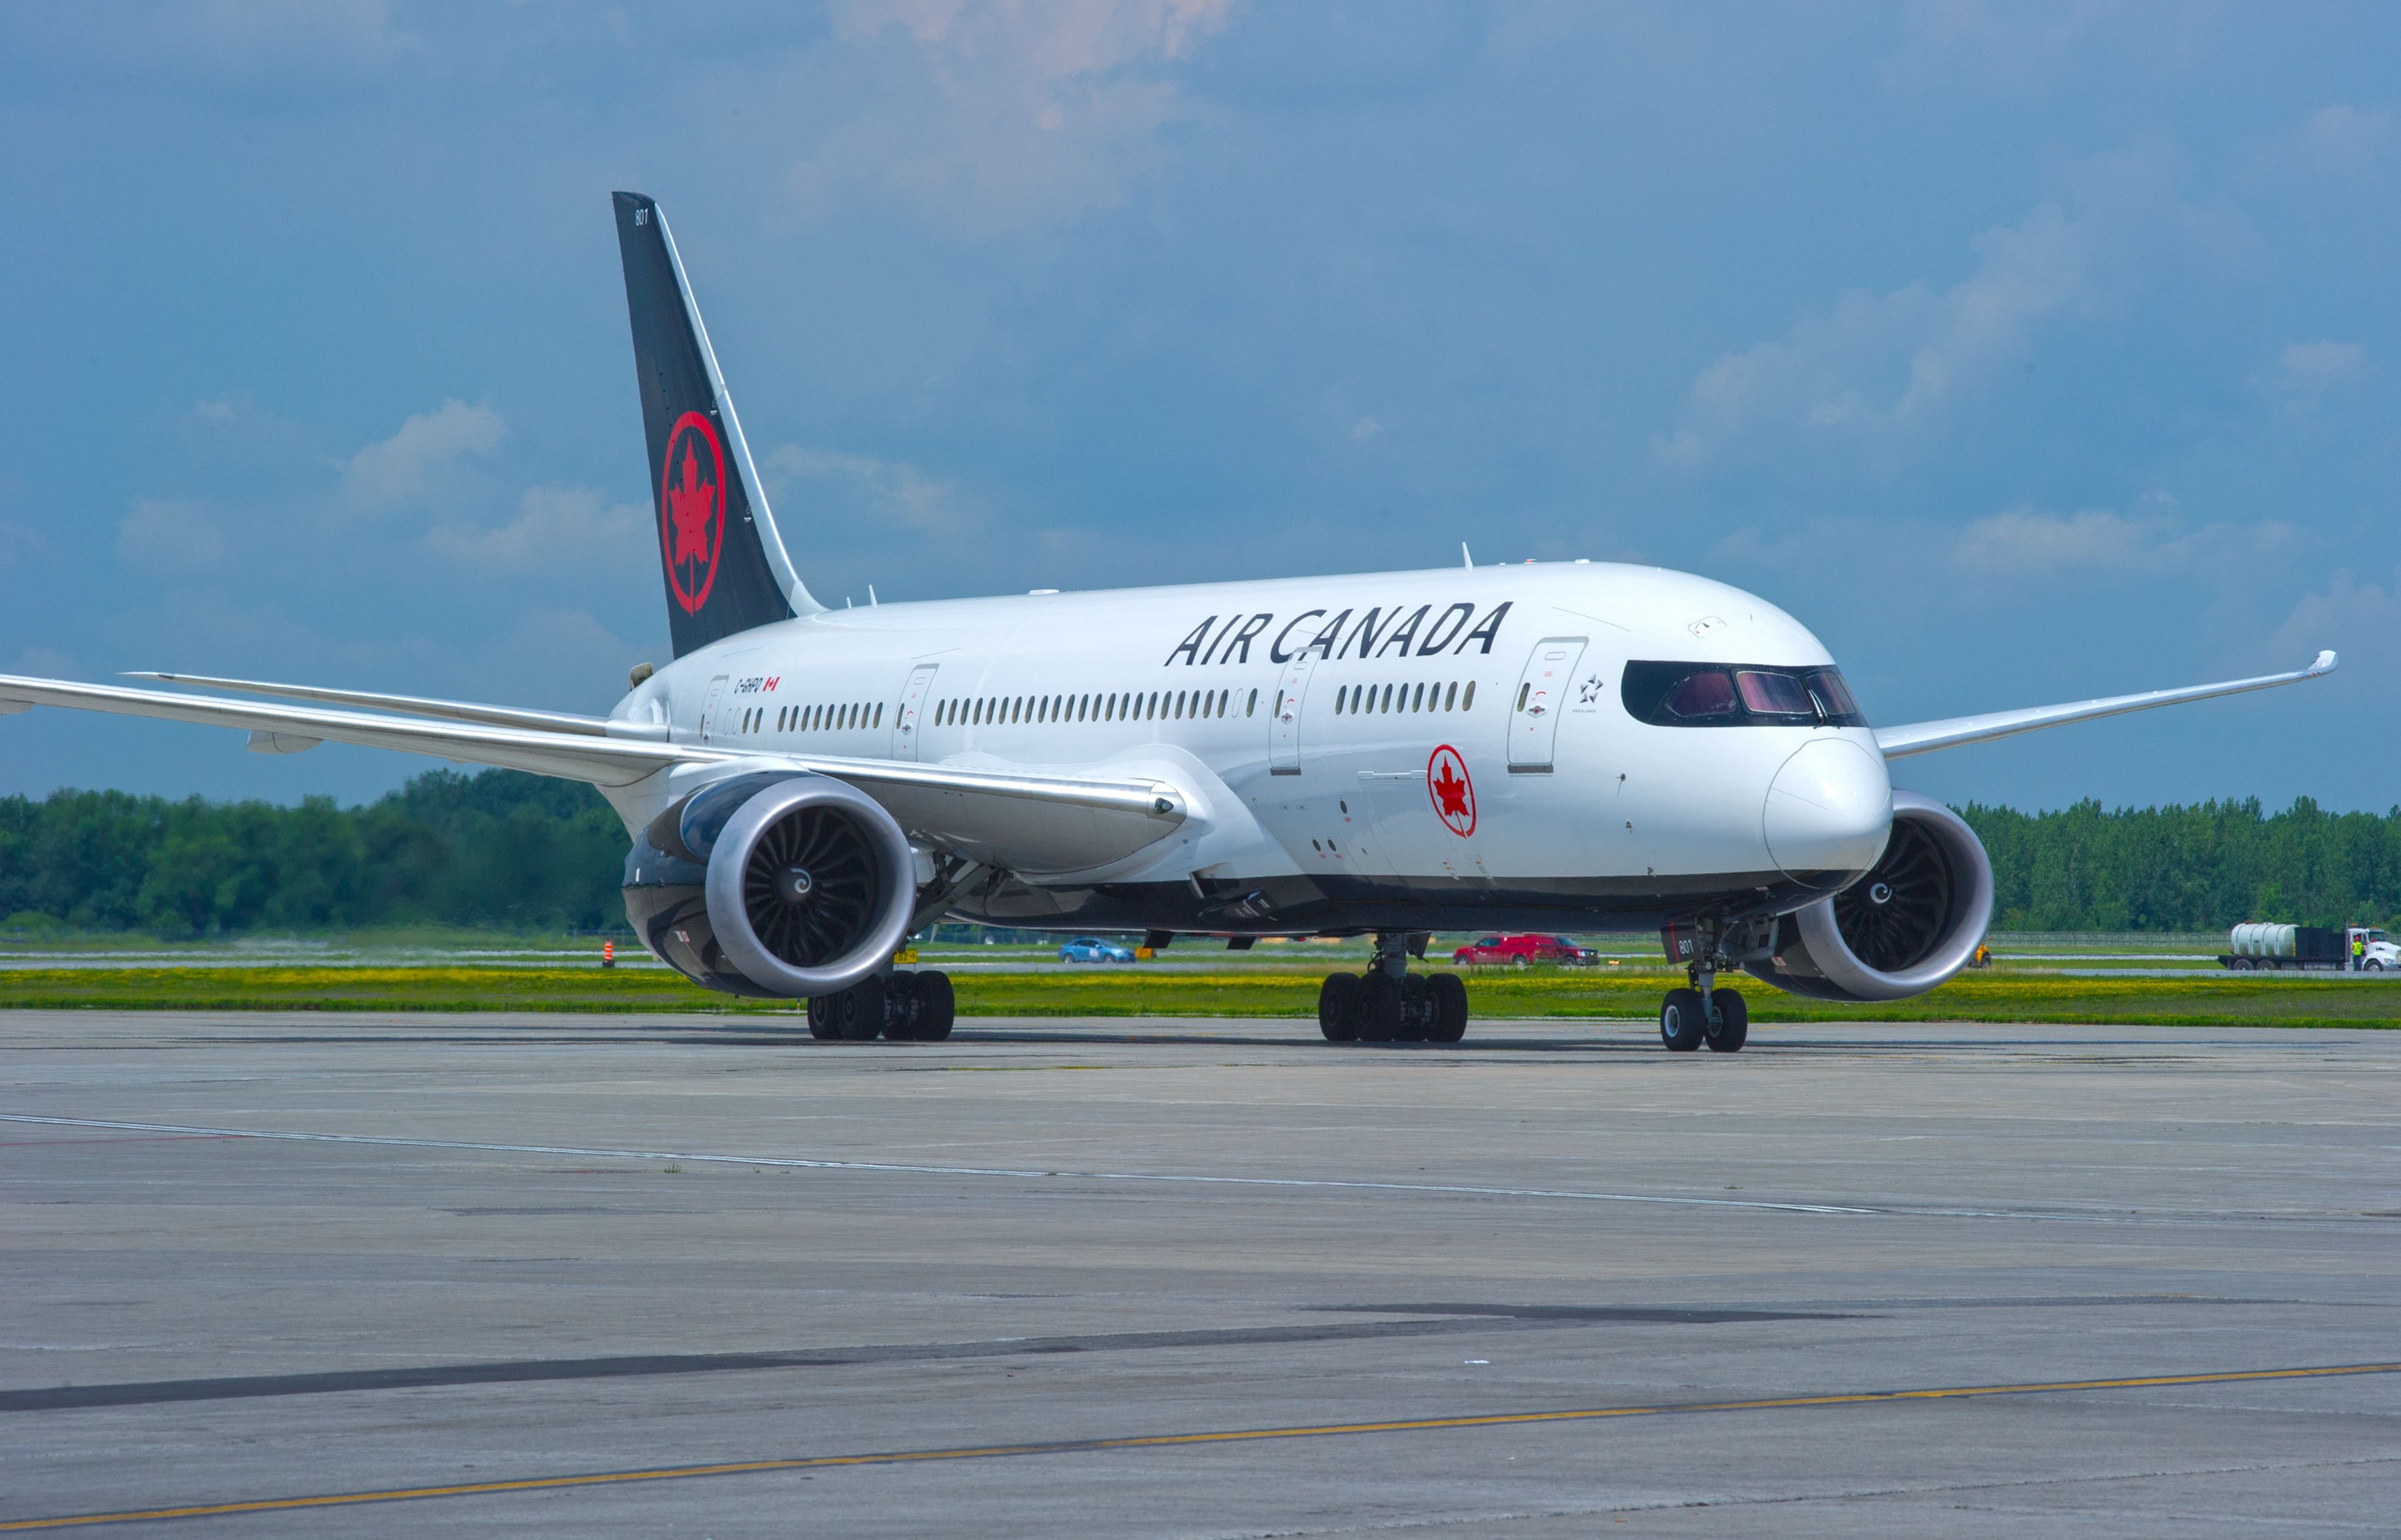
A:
0 958 2401 1028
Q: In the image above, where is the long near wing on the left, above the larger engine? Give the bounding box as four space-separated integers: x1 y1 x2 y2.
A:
0 675 1188 872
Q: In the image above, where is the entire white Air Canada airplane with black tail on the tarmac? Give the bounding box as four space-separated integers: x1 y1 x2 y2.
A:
0 192 2336 1052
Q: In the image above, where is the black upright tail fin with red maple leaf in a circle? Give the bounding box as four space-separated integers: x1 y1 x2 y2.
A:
617 192 824 658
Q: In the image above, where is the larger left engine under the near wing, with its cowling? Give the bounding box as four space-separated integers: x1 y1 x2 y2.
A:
624 771 917 1000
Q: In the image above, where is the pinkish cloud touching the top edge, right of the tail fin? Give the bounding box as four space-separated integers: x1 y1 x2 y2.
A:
792 0 1234 233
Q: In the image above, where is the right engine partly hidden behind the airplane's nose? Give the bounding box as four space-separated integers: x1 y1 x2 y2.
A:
1743 790 1993 1002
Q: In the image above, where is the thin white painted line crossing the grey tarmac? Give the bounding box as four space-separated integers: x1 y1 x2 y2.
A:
0 1112 1887 1213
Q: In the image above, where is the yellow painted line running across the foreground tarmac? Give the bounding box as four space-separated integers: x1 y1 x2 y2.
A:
0 1362 2401 1533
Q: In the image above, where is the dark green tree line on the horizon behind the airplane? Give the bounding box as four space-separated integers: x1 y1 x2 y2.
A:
0 771 2401 937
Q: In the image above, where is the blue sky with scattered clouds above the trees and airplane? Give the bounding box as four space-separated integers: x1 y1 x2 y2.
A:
0 0 2401 812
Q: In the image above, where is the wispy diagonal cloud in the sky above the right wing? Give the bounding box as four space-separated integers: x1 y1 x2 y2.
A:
1654 151 2224 466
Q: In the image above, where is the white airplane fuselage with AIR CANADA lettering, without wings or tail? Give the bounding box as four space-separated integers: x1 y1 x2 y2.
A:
610 562 1889 932
